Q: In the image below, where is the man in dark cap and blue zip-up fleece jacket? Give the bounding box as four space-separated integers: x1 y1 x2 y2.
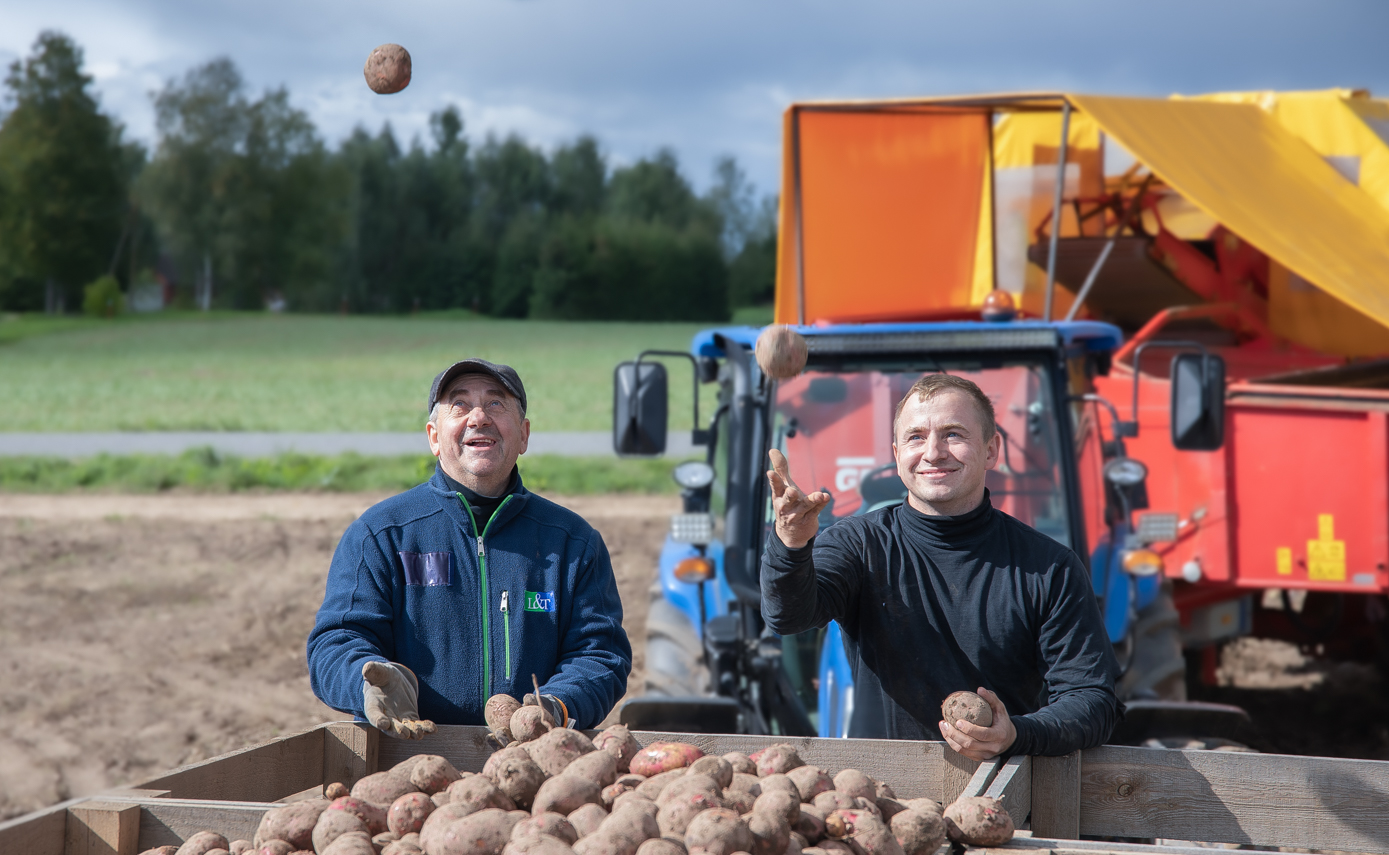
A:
308 359 632 738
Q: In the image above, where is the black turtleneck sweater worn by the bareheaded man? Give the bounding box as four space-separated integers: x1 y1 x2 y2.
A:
761 493 1120 755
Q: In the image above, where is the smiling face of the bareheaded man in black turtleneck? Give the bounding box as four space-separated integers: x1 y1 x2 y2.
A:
892 389 1003 516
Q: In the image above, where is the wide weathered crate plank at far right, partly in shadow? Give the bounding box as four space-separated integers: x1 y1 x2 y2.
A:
1079 745 1389 852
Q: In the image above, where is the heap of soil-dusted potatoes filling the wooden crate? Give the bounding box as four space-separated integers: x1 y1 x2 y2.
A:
143 698 1013 855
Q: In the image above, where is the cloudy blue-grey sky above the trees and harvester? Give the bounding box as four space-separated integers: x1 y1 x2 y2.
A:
0 0 1389 192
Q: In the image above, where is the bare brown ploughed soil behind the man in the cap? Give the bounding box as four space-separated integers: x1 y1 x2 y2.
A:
0 494 679 820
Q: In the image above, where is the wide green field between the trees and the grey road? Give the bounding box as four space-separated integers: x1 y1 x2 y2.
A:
0 312 738 432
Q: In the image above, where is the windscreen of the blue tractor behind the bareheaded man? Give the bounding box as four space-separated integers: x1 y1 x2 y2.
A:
768 361 1071 545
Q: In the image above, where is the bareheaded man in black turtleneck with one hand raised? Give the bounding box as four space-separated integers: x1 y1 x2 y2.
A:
761 373 1118 761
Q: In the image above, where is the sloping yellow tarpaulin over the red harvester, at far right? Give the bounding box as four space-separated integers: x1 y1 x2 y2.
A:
1070 96 1389 353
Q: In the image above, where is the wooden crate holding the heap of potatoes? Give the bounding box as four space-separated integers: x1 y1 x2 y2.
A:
0 722 1389 855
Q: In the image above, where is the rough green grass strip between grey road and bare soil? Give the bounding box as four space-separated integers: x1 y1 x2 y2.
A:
0 448 679 496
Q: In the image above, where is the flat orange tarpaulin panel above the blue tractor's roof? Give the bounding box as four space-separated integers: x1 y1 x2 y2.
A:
776 107 990 323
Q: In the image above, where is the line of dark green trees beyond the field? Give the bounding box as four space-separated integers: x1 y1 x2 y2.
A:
0 32 776 321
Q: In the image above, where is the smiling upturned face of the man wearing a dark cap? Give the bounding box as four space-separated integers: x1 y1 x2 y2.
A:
425 373 531 496
